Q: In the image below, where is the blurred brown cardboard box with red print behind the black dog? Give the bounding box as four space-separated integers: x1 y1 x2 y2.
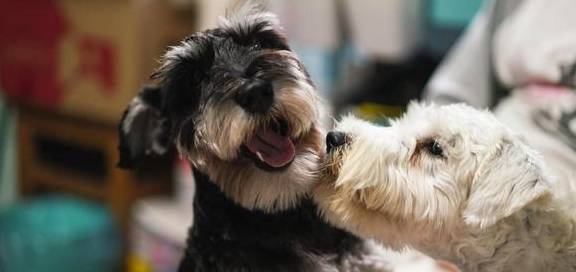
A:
0 0 195 122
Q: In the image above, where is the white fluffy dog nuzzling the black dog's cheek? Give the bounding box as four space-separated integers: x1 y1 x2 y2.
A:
315 104 576 272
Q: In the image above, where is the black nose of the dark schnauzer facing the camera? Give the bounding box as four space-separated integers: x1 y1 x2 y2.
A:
236 80 274 113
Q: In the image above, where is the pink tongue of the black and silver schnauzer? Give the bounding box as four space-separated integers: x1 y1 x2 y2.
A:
246 129 296 167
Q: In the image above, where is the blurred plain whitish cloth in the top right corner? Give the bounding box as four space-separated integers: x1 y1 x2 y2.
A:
492 0 576 89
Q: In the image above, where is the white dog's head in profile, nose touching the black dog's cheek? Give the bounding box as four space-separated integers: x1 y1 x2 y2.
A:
316 104 549 244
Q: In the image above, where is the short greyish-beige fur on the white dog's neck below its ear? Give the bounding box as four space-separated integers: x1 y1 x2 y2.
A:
417 203 576 272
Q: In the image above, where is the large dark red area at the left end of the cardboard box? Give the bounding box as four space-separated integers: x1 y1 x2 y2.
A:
0 0 67 106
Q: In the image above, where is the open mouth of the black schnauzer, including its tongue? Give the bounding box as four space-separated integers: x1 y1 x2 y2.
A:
244 121 296 171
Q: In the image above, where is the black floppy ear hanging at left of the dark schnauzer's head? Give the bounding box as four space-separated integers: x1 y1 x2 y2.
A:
118 86 170 168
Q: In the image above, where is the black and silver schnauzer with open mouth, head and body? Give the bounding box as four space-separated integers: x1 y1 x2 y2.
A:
119 2 383 271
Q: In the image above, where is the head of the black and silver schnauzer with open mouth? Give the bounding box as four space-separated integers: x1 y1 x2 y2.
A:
120 2 323 211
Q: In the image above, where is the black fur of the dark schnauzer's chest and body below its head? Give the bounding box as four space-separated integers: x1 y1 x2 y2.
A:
179 173 361 272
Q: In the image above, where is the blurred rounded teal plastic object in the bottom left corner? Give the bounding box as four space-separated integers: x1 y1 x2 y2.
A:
0 195 121 272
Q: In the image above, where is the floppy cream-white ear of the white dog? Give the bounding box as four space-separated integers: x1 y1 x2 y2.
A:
463 141 550 228
